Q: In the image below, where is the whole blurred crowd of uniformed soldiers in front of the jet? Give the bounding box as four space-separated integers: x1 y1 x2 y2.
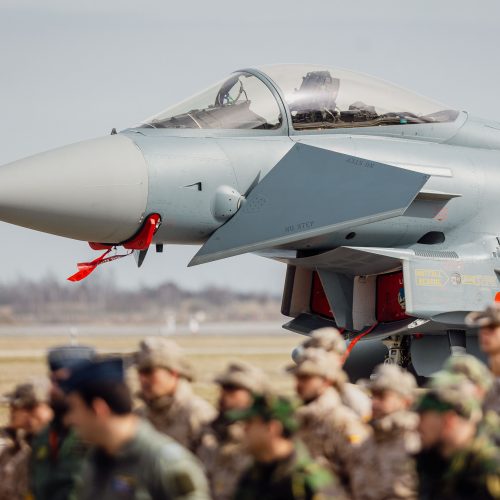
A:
0 307 500 500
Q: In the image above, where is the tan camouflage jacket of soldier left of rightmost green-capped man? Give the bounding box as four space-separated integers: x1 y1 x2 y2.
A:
351 411 420 500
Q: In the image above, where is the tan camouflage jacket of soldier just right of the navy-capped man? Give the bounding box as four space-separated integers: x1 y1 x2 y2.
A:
138 380 216 452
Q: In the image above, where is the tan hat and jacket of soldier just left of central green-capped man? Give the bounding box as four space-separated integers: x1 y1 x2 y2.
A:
196 362 266 500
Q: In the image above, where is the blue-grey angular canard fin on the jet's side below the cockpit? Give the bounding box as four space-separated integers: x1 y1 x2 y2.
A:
190 144 429 265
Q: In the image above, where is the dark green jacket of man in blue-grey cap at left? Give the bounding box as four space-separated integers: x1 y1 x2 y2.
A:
30 423 87 500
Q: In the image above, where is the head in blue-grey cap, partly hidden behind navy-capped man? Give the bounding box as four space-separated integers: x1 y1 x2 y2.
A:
47 345 95 417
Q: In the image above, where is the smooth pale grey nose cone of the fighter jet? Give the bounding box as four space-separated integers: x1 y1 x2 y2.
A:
0 134 148 243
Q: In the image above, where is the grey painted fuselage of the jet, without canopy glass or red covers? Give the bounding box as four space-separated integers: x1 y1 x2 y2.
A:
0 63 500 376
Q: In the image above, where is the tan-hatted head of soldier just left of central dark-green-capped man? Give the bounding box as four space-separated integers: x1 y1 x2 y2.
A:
215 361 267 412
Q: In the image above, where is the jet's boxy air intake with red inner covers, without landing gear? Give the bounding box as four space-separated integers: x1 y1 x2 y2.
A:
278 247 500 334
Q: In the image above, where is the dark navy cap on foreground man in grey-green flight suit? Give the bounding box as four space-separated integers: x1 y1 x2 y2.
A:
61 358 125 393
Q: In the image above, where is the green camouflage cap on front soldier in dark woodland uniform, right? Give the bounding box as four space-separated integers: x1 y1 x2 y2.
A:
416 372 482 421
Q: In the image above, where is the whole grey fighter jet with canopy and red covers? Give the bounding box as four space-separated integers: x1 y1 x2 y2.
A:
0 65 500 377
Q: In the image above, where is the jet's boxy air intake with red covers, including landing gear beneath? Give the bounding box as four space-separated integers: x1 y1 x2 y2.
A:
279 247 494 381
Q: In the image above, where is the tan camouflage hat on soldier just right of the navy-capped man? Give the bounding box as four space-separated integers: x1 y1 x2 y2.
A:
134 337 194 380
